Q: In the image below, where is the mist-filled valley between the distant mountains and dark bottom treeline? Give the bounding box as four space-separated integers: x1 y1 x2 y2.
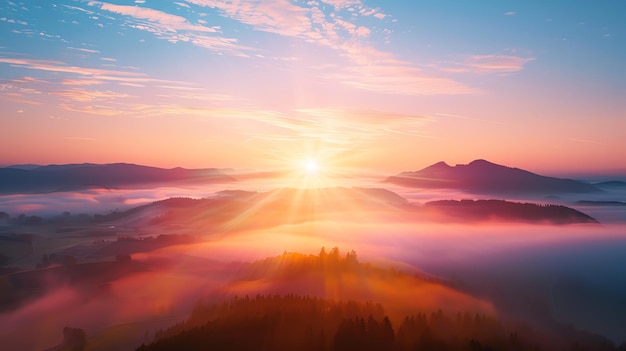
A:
0 163 626 350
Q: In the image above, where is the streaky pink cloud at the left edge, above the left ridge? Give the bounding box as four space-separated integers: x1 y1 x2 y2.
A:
0 57 235 117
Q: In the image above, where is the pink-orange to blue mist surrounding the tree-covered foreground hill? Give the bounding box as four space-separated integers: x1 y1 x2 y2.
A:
0 218 626 350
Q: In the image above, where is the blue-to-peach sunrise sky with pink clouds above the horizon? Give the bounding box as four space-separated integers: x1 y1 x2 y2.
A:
0 0 626 174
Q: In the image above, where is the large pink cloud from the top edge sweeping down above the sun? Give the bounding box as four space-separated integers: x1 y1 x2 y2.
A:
187 0 477 95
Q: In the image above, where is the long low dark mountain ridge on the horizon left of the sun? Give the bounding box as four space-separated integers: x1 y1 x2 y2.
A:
0 163 236 194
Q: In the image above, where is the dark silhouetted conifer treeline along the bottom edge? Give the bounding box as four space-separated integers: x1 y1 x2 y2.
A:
137 295 626 351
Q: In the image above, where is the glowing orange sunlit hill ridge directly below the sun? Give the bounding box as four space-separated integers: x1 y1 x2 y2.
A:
90 187 407 233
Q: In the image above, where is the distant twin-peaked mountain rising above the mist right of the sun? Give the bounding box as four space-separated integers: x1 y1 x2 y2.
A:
385 160 602 195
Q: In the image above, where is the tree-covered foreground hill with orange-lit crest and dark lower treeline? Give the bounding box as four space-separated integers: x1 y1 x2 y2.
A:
137 249 616 351
